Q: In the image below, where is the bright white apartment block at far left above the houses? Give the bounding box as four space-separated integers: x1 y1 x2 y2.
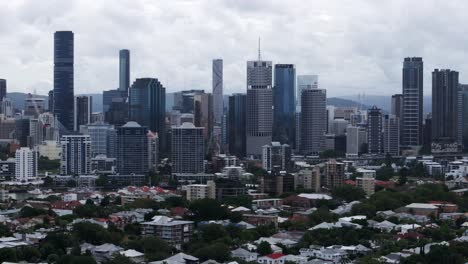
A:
15 148 38 182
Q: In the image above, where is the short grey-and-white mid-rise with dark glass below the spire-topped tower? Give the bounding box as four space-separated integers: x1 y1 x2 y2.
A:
262 142 291 171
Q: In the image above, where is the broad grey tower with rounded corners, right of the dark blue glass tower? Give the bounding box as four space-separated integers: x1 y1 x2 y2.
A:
300 89 327 155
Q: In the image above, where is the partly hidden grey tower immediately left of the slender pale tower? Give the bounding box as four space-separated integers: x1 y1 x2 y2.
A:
193 93 213 139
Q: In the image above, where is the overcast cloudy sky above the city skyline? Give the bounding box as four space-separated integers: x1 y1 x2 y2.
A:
0 0 468 96
